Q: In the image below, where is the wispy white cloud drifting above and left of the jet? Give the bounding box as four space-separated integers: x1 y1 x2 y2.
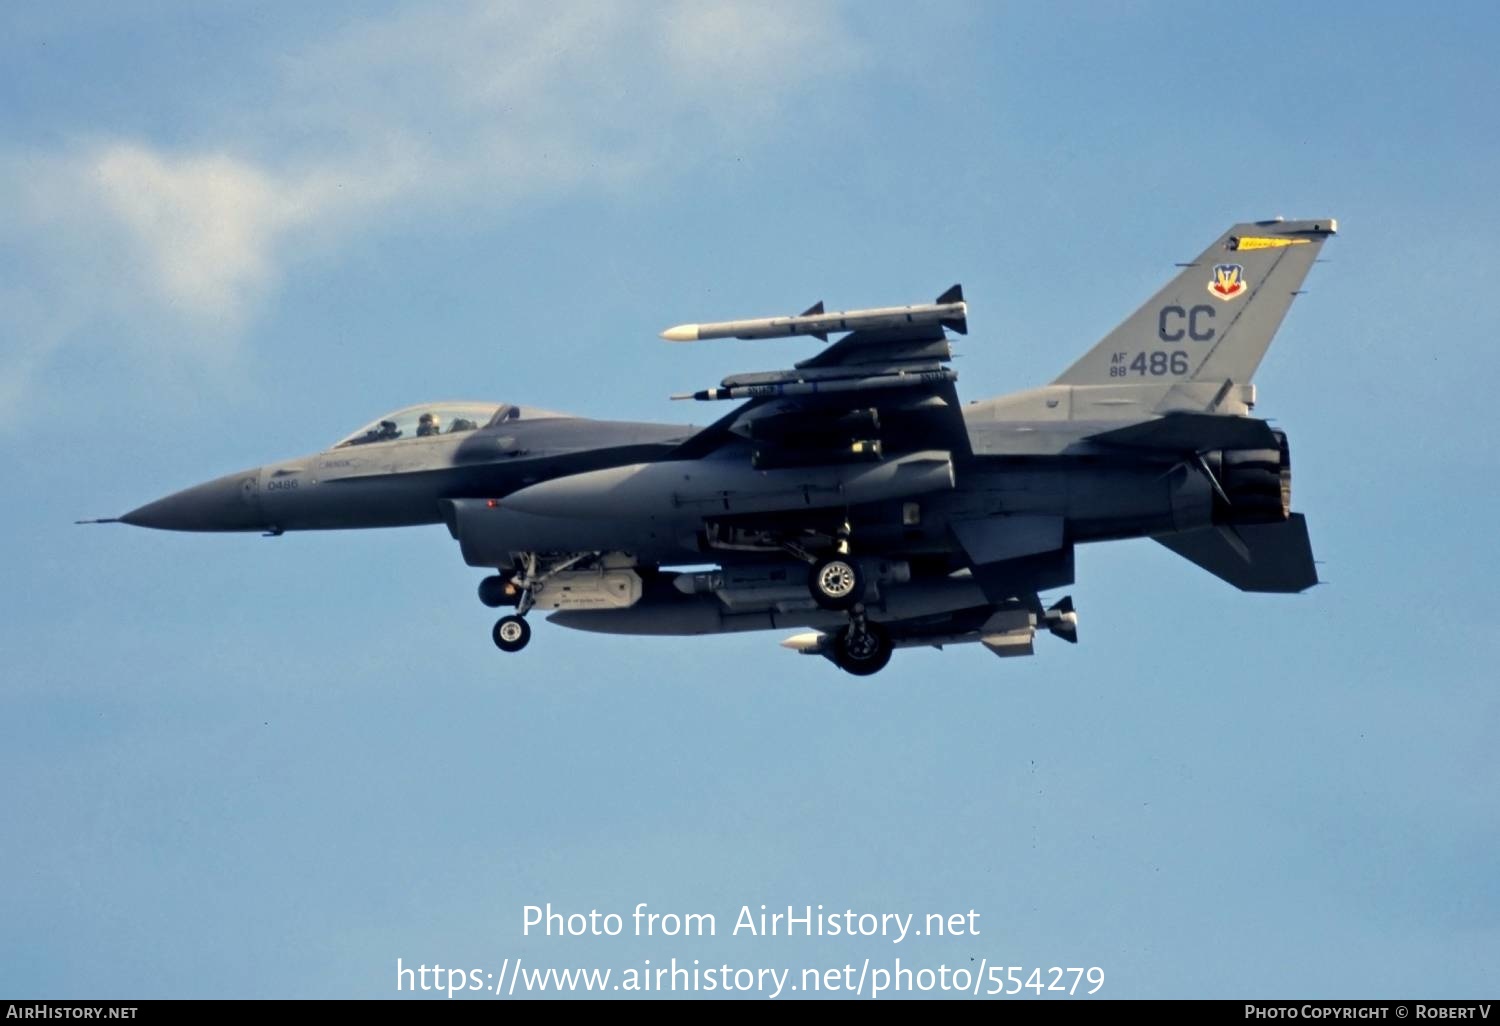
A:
0 0 855 417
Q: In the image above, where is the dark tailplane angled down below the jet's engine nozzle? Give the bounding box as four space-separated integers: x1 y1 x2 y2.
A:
1157 513 1317 594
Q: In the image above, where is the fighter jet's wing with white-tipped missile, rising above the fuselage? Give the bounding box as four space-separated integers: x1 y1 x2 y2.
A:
663 285 969 468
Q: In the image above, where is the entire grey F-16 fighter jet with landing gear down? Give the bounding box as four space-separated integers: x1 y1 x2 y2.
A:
90 218 1337 675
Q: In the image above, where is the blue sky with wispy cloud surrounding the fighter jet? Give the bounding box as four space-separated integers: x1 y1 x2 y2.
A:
0 3 1500 998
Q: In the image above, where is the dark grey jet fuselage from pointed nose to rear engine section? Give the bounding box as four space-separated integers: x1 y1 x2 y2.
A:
122 416 1230 567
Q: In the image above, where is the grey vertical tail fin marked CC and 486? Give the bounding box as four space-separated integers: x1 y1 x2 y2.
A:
1053 218 1338 386
